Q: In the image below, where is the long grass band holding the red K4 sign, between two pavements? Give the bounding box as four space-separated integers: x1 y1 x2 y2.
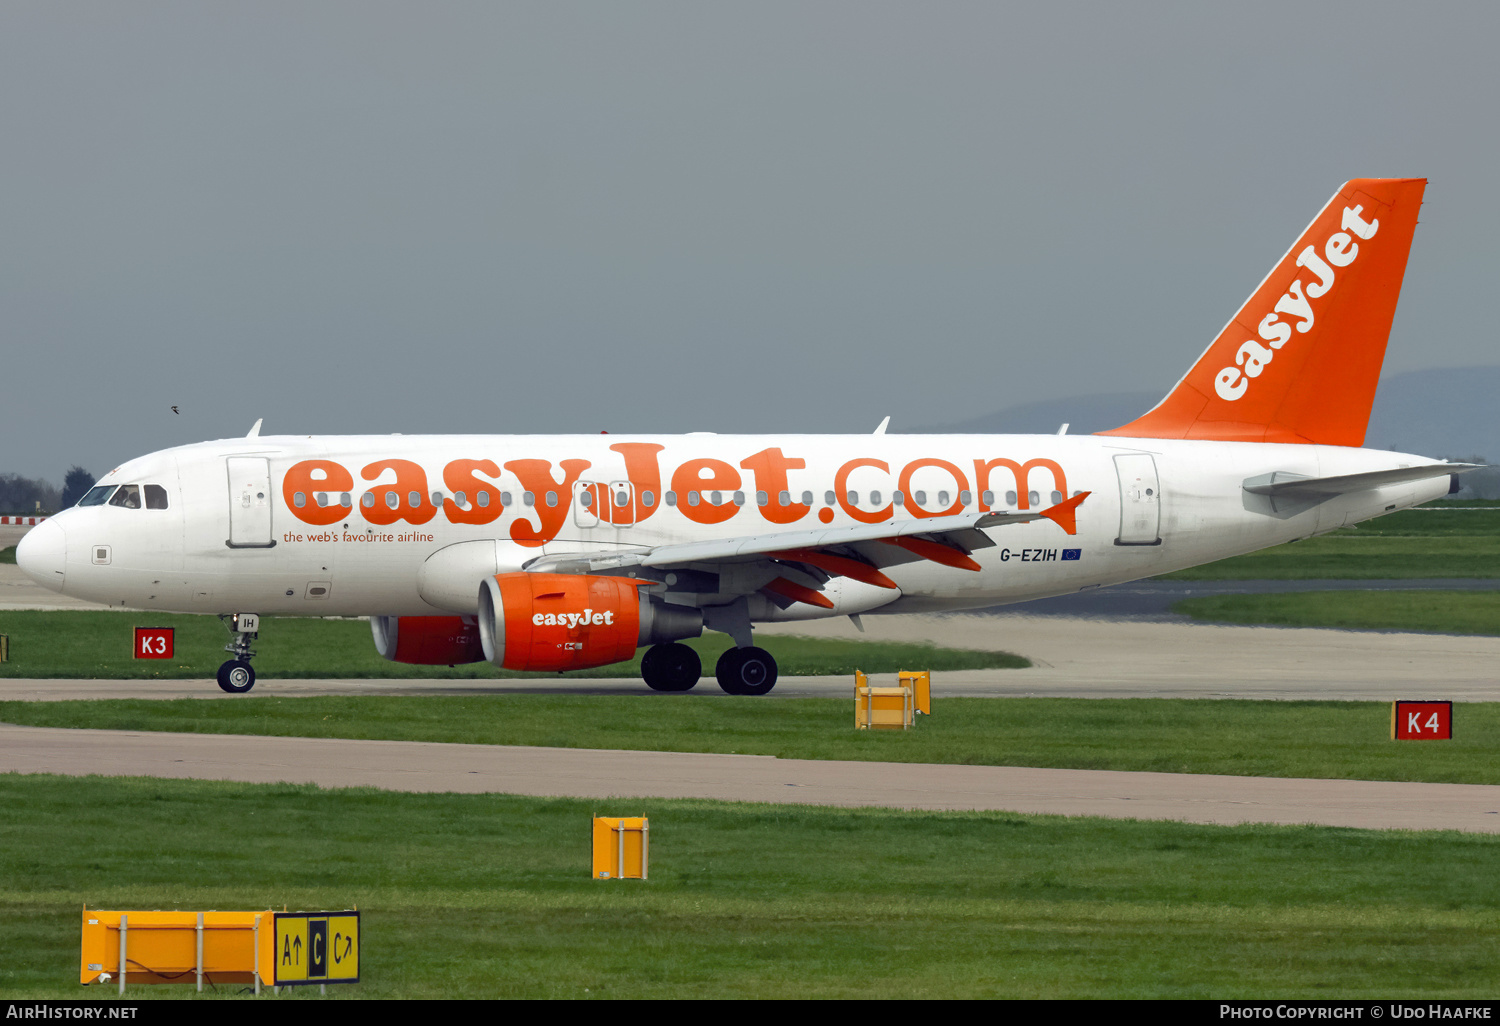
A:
0 696 1500 785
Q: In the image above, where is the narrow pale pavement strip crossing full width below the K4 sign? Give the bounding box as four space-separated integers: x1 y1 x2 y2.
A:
0 725 1500 834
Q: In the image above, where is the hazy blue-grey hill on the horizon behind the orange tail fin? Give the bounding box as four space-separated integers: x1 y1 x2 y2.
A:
917 366 1500 498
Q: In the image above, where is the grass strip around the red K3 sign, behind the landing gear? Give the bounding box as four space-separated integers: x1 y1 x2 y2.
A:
0 611 1031 680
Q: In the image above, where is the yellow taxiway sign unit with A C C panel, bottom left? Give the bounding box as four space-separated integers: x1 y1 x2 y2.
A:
78 909 360 986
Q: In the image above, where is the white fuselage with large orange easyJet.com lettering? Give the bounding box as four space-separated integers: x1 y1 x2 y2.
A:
26 435 1449 621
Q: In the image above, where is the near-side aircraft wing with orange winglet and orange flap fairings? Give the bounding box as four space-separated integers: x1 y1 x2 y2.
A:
525 492 1089 608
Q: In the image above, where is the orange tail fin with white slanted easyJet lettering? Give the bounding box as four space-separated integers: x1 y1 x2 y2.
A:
1100 179 1427 446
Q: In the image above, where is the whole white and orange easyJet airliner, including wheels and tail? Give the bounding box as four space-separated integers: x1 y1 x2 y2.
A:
17 179 1467 695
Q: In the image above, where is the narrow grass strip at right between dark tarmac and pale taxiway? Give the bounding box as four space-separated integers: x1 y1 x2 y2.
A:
1172 591 1500 635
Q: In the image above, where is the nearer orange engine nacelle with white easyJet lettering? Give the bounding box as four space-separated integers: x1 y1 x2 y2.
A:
479 573 704 671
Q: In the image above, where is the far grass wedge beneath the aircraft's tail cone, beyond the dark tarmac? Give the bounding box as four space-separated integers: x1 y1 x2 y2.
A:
1161 501 1500 581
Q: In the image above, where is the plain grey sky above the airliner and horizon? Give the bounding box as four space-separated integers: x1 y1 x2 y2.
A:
0 0 1500 482
